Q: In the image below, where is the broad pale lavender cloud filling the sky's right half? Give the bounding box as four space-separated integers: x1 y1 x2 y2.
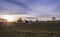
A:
26 0 60 17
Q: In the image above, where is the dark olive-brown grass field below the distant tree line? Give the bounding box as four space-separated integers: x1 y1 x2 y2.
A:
0 22 60 37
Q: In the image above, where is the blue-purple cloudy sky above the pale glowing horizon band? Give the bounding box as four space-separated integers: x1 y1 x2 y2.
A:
0 0 60 17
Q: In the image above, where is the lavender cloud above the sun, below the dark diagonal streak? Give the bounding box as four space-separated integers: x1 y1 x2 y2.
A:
0 0 29 14
